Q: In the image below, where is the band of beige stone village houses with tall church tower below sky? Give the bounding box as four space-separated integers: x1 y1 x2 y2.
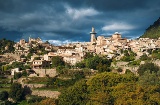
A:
9 27 160 75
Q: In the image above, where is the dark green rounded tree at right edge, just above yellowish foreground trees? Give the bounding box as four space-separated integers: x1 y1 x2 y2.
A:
138 63 159 75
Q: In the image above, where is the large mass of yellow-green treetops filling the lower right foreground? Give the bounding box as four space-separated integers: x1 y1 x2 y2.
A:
59 72 160 105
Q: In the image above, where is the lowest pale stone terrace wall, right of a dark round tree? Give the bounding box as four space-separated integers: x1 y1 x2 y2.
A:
31 90 60 99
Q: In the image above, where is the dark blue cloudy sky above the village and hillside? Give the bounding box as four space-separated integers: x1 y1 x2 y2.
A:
0 0 160 44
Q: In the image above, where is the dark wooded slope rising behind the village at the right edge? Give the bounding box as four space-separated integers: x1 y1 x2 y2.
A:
140 17 160 39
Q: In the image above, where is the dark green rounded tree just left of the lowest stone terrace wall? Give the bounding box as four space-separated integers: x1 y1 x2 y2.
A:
9 83 24 101
